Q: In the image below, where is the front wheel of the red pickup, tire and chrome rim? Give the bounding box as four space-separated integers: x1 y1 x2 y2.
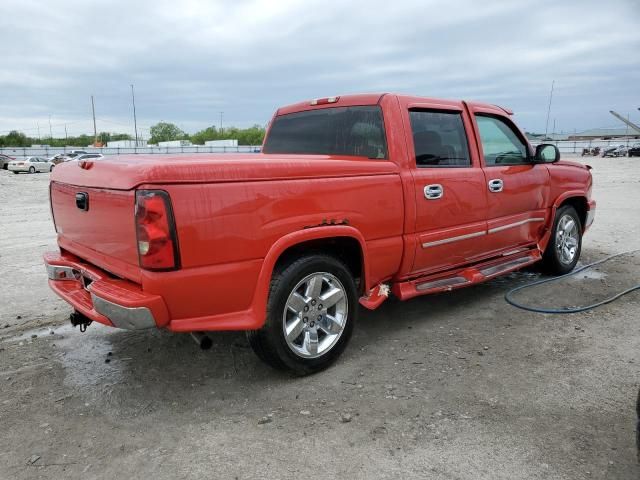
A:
542 205 582 275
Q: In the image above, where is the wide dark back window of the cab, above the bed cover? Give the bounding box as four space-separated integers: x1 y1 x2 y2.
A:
262 106 387 158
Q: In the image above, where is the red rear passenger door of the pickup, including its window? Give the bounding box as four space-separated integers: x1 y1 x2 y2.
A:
404 102 487 274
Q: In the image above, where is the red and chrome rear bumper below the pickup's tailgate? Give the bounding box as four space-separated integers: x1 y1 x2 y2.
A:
44 252 169 330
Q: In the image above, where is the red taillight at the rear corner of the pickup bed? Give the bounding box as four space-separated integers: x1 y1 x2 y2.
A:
136 190 180 270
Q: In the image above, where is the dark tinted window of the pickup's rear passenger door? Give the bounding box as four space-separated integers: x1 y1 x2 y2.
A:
409 110 471 167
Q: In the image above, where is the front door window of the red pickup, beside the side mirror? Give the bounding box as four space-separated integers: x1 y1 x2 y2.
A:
476 115 529 166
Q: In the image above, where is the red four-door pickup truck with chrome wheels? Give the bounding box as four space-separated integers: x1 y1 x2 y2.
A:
45 94 595 374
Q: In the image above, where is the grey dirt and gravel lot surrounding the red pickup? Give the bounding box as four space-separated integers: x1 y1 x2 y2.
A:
0 158 640 480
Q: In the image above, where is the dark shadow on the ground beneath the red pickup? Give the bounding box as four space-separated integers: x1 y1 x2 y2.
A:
45 272 535 416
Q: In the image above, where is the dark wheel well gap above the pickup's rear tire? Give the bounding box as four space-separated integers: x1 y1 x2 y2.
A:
274 237 364 290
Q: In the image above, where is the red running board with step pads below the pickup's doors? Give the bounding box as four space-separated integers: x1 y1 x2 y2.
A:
392 249 542 300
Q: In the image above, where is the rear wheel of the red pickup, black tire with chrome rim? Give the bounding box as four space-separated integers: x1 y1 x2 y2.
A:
247 255 358 375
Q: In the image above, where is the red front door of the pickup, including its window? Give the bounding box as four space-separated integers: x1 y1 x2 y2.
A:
464 107 549 254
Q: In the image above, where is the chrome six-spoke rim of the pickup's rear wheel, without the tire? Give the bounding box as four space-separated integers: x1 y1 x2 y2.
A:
282 272 349 358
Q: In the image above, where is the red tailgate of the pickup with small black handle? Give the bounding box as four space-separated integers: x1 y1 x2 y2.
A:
51 182 140 282
